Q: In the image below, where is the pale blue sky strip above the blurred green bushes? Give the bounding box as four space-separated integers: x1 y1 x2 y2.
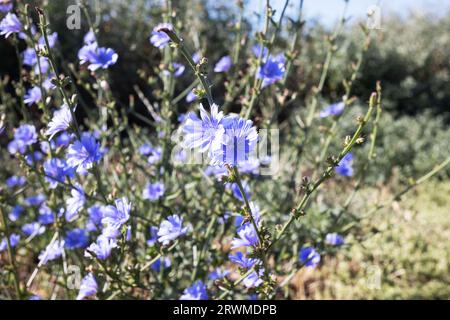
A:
247 0 450 26
